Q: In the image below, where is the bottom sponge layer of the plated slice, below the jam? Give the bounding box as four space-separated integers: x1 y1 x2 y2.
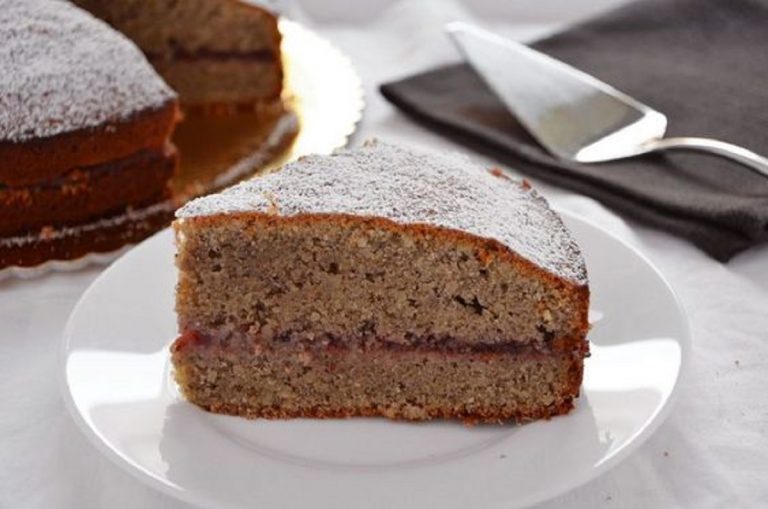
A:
172 330 582 422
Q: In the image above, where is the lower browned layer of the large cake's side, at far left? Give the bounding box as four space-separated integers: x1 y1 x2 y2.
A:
0 145 176 236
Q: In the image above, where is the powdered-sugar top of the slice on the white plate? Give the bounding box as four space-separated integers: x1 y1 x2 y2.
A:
176 141 587 285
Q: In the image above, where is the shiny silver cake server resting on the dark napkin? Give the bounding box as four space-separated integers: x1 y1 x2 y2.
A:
446 22 768 177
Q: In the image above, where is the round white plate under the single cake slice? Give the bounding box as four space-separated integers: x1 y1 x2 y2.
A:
61 211 690 509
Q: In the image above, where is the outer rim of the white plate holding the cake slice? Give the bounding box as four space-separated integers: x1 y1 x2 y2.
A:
57 206 692 508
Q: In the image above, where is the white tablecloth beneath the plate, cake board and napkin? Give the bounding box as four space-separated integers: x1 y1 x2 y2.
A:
0 0 768 509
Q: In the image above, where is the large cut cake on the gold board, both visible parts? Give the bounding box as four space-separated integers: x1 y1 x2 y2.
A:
0 0 296 270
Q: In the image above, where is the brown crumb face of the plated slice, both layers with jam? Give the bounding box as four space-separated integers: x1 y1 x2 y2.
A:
173 213 586 421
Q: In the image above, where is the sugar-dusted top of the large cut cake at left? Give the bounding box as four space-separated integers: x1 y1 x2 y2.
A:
0 0 175 142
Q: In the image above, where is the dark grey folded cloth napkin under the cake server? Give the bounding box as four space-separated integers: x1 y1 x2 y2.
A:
381 0 768 261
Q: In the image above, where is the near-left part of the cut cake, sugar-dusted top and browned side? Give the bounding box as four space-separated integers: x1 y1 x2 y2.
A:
0 0 179 269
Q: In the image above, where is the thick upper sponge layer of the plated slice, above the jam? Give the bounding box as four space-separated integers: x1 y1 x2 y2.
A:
176 213 588 350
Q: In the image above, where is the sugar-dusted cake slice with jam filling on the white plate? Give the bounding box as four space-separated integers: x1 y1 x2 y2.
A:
172 143 589 422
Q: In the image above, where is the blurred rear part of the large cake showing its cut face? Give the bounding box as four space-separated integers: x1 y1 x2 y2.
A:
74 0 283 114
